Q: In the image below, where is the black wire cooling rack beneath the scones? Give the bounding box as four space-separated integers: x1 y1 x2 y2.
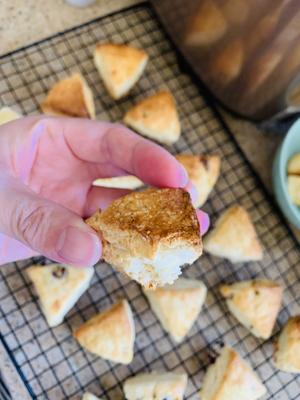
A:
0 6 300 400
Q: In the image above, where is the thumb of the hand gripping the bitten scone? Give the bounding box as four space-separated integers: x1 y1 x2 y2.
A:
0 178 101 266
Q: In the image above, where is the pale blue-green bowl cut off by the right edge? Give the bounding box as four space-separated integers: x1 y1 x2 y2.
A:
273 119 300 229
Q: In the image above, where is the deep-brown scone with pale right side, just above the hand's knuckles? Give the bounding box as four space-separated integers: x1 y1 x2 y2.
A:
41 73 95 118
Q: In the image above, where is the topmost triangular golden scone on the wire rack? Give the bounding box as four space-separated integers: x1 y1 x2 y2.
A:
94 43 148 100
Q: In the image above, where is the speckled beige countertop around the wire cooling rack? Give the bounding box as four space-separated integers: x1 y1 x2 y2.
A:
0 0 300 400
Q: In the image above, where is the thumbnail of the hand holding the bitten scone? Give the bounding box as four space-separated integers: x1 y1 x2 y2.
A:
56 226 101 267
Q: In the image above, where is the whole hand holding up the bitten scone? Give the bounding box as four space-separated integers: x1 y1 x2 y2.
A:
0 117 209 266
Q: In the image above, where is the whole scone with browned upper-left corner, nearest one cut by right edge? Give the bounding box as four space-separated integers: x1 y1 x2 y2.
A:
220 280 283 339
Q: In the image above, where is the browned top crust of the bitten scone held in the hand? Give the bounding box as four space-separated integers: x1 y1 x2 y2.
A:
87 189 200 244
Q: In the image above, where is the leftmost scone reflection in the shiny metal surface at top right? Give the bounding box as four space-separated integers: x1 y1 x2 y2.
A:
185 0 228 46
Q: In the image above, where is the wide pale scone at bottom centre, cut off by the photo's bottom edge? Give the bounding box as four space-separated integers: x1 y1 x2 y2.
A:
123 372 187 400
